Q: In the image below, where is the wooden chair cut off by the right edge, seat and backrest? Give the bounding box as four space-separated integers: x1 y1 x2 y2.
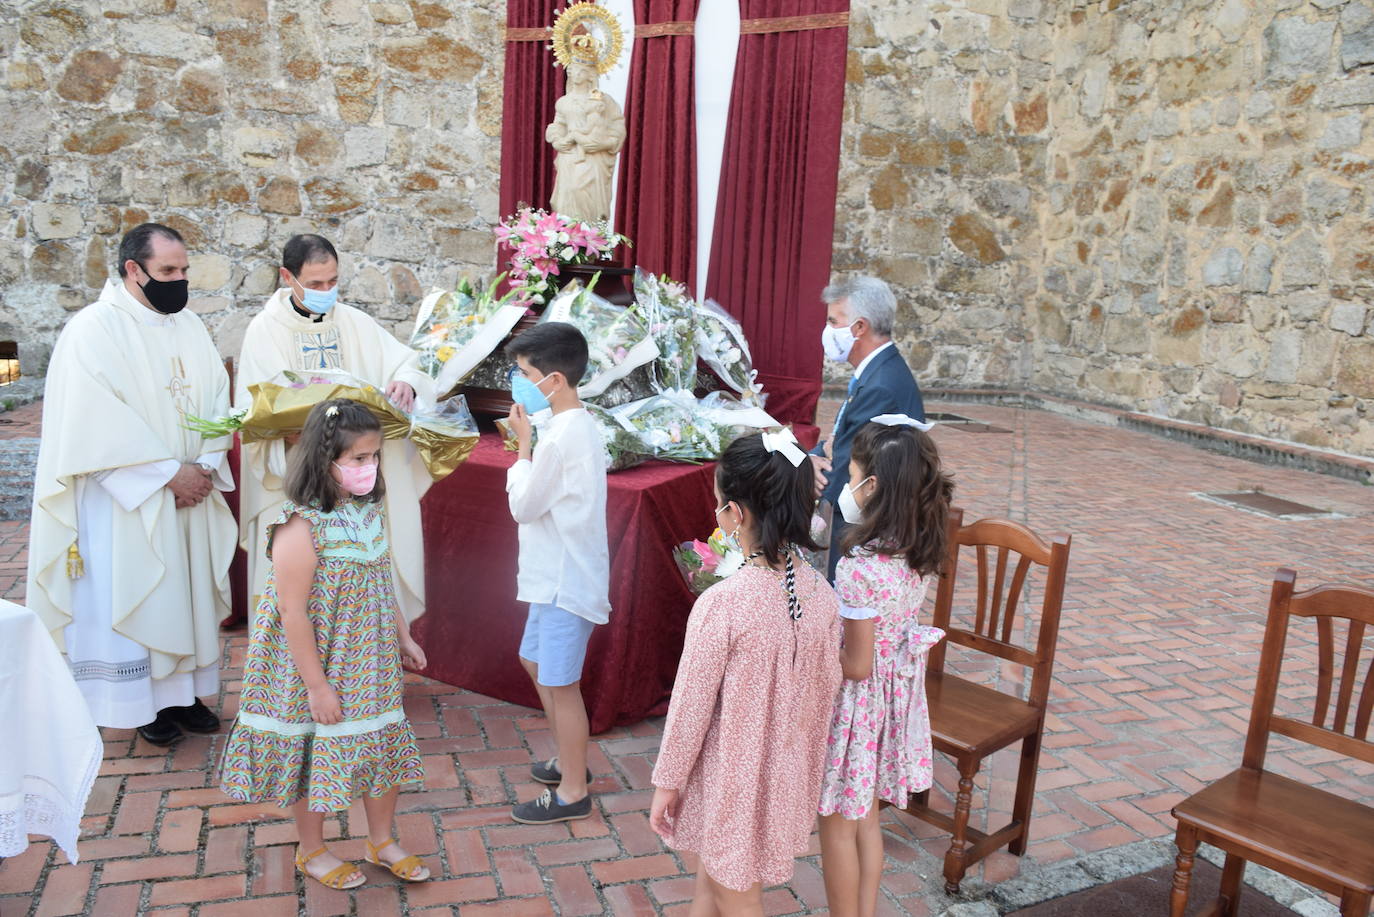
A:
1169 569 1374 917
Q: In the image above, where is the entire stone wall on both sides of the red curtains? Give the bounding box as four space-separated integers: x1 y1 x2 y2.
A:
0 0 1374 454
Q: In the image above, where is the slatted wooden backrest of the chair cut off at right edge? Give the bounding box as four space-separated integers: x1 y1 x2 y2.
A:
1241 568 1374 769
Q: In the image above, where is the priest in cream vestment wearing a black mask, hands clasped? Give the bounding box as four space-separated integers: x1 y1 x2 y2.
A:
27 224 235 745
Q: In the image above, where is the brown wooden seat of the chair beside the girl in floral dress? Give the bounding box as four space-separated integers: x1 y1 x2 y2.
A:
926 672 1040 756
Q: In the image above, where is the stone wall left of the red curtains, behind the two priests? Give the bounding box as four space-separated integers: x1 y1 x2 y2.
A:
0 0 506 373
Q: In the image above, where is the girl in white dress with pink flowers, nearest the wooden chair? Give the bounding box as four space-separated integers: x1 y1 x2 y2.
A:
820 414 954 917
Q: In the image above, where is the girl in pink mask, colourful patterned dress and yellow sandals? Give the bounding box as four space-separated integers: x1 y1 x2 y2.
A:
220 399 429 890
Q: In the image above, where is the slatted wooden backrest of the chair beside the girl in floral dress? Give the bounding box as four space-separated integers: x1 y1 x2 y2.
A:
929 518 1073 708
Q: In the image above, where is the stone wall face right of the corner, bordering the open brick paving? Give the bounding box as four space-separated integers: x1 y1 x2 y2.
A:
1026 0 1374 455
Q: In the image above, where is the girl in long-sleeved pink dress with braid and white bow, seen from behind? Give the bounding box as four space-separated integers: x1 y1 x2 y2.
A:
650 430 840 914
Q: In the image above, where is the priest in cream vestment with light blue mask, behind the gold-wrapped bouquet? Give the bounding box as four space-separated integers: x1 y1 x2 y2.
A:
234 234 434 621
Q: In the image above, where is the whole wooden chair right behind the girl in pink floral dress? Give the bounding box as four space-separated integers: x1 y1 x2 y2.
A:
907 520 1072 895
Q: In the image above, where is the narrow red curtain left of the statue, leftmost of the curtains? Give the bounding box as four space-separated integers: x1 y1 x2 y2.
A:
502 0 563 219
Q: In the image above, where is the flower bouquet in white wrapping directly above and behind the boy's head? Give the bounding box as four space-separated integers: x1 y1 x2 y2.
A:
540 280 658 399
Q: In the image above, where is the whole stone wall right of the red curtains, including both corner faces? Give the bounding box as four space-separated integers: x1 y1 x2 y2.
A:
835 0 1374 455
